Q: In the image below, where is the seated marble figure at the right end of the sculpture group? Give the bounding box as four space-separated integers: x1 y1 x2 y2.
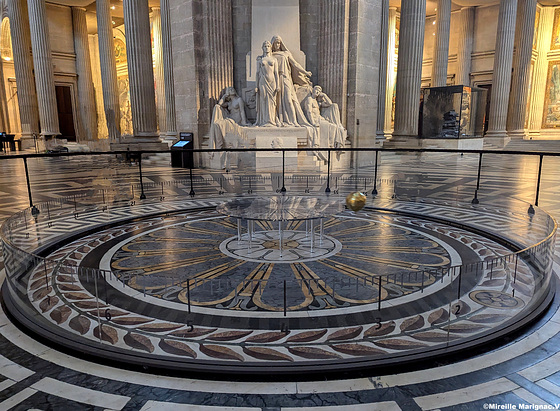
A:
302 86 347 156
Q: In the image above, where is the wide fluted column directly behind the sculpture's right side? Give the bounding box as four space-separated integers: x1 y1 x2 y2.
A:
318 0 350 126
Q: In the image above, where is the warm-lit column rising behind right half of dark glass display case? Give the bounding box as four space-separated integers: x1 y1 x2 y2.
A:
455 7 475 86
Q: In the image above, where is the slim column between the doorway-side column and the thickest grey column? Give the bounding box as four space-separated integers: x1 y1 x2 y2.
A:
95 0 121 141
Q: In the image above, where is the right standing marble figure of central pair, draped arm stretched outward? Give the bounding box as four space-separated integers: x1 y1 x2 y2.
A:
272 36 311 127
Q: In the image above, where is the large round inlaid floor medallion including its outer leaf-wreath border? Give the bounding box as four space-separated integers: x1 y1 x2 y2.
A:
19 206 535 366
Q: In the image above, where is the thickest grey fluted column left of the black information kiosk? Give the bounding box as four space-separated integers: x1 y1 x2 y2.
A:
123 0 157 141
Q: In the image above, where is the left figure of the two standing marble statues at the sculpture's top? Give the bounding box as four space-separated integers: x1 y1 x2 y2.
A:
255 41 281 127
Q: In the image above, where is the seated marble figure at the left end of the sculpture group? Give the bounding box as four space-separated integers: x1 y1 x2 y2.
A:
209 87 249 169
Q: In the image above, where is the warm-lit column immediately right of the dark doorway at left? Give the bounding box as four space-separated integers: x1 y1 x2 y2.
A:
72 7 97 141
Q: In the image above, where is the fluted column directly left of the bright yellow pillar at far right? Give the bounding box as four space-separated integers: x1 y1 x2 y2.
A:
507 0 537 139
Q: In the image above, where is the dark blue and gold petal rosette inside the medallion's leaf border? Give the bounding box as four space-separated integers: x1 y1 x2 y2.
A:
107 215 457 311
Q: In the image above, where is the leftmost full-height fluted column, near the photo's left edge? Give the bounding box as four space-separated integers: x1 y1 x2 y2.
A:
8 0 39 148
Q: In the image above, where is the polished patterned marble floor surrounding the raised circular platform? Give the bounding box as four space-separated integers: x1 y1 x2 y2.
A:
0 142 560 410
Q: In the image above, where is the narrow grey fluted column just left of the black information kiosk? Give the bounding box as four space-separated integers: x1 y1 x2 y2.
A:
160 0 177 142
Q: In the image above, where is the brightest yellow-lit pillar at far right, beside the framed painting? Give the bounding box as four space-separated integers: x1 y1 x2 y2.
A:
529 7 554 138
